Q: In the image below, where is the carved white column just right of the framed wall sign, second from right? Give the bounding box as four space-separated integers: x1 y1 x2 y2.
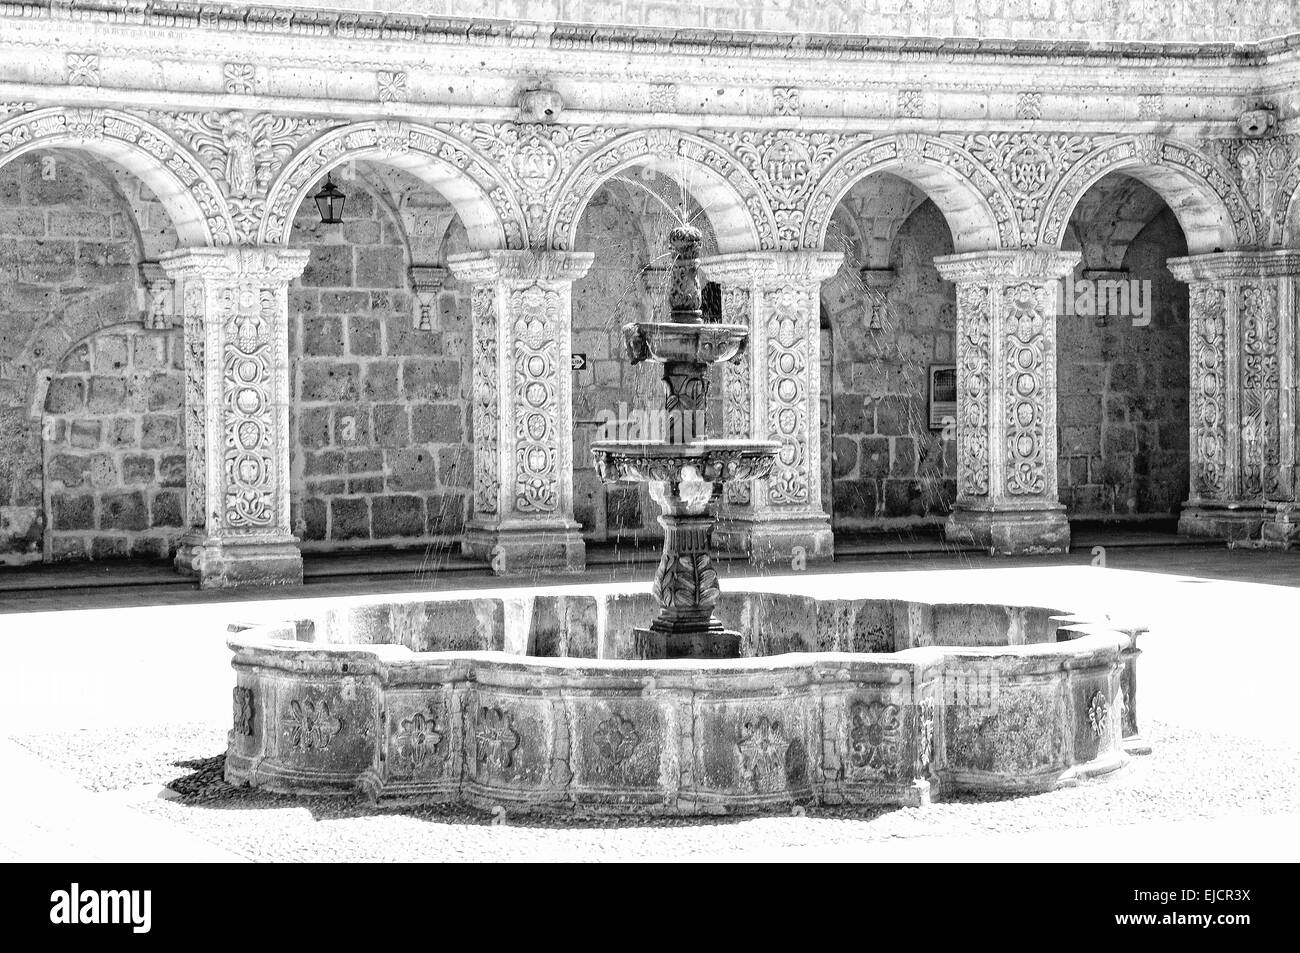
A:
935 248 1079 554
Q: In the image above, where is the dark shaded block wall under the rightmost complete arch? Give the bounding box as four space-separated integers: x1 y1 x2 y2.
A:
1057 196 1190 520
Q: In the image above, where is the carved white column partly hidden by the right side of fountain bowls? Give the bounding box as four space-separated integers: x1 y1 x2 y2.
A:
701 251 844 564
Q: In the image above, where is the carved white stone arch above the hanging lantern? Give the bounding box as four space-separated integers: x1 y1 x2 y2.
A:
259 120 527 248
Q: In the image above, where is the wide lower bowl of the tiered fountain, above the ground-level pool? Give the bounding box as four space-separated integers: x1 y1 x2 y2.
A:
592 439 781 484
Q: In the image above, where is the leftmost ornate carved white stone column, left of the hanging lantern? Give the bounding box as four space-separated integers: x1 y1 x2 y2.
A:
161 247 308 589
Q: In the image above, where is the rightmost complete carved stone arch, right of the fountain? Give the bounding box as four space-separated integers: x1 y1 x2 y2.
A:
1037 135 1255 255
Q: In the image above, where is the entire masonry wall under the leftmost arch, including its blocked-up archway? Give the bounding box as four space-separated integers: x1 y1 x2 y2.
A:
0 151 185 563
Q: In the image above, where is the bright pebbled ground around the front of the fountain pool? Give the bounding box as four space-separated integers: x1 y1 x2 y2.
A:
13 723 1300 861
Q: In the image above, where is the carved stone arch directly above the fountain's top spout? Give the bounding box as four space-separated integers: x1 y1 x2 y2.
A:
546 129 776 254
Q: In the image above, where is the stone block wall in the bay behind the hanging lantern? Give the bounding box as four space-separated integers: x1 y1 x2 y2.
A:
290 168 473 551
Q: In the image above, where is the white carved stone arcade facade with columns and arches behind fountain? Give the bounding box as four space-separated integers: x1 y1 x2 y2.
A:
0 0 1300 585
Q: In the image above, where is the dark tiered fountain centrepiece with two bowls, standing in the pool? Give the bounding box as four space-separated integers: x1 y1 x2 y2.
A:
592 225 781 659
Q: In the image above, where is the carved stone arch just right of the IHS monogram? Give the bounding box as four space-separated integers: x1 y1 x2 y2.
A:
803 134 1018 252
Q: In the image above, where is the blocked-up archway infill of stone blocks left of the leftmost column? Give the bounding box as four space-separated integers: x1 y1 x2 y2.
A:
44 326 185 560
